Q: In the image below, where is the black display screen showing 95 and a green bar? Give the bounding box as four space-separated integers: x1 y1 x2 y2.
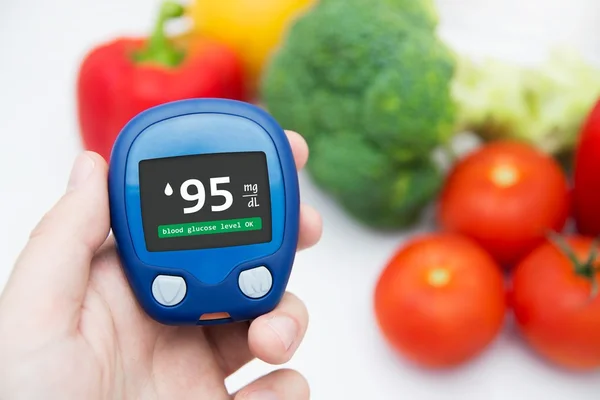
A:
139 152 271 252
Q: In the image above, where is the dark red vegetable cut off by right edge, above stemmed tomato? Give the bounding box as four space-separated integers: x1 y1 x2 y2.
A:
573 101 600 237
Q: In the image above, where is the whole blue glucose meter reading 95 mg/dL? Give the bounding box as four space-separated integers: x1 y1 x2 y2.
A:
109 99 300 325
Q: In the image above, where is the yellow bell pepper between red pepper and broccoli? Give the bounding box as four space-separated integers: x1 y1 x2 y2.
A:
188 0 317 98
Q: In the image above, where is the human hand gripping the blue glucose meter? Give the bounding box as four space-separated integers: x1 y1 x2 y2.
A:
0 132 321 400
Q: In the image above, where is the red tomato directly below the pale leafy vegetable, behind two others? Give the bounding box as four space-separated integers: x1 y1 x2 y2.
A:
438 142 570 266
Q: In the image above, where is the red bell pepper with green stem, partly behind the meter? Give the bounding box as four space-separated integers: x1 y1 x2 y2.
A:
77 1 245 160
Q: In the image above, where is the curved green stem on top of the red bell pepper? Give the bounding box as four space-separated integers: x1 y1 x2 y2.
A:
133 0 185 67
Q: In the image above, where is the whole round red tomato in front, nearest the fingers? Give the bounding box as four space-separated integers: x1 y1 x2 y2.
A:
374 234 506 368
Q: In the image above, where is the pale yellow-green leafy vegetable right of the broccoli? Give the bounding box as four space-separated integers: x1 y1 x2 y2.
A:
452 50 600 156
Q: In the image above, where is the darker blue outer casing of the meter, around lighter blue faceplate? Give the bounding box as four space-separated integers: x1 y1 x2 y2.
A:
108 99 300 325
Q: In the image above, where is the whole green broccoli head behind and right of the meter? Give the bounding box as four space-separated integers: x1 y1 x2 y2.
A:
262 0 454 227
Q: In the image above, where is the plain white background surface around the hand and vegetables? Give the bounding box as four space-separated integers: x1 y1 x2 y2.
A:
0 0 600 400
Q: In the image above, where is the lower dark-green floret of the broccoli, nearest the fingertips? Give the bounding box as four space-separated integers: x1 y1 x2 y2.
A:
308 132 443 229
